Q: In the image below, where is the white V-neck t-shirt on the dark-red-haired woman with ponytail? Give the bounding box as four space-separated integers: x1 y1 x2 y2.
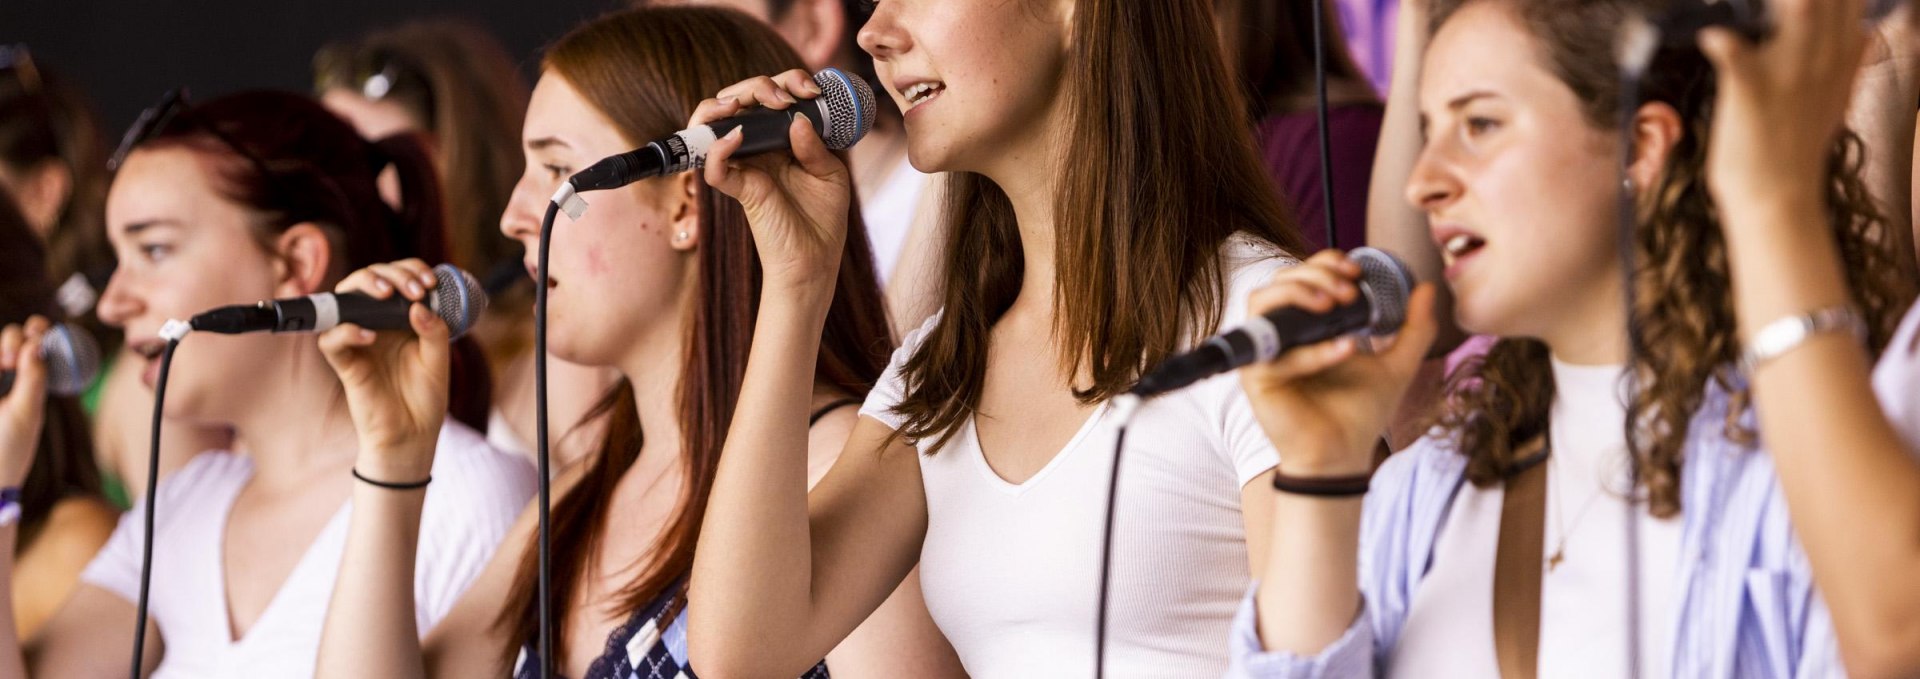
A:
81 420 536 679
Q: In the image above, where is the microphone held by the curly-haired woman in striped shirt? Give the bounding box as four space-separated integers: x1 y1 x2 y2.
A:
1129 247 1413 399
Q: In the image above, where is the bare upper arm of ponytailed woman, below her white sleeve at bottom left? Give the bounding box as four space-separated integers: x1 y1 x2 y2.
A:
27 583 163 677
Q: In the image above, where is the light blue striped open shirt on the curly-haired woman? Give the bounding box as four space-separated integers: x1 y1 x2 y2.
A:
1229 374 1873 679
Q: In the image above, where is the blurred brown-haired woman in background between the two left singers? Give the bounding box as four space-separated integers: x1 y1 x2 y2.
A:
313 19 616 470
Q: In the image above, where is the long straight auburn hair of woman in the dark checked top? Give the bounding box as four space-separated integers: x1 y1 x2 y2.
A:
495 8 893 664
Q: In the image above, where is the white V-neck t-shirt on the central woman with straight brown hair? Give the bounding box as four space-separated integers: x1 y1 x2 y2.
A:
860 238 1290 679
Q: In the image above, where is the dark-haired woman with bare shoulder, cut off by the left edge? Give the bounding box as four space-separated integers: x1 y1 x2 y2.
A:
0 190 119 648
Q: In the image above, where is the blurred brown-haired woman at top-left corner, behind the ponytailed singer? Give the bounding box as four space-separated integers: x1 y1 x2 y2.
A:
0 46 228 506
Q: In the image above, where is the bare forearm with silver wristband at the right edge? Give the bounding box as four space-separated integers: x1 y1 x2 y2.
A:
1728 199 1920 671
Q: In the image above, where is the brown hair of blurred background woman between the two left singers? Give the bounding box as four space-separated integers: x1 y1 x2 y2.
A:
313 19 528 278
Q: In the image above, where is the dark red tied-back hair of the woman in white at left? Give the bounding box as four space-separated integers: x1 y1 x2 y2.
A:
128 92 492 432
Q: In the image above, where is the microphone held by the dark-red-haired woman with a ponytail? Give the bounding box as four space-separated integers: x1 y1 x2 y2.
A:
190 265 486 338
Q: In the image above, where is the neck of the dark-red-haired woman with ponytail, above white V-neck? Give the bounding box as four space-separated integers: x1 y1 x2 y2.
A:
232 336 359 487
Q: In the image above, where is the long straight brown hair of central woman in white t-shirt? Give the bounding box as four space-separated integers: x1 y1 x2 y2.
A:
895 0 1306 447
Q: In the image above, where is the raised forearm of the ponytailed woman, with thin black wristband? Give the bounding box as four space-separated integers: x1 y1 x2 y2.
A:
315 455 432 677
